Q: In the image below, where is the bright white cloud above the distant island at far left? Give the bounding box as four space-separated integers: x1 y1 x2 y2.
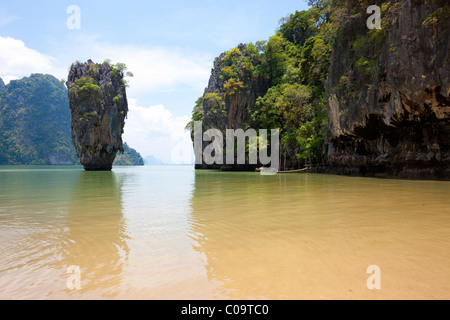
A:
0 36 67 83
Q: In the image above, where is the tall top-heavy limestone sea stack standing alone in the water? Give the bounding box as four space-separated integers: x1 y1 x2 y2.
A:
67 60 128 171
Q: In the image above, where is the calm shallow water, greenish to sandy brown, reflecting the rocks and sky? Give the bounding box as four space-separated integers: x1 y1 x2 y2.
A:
0 166 450 299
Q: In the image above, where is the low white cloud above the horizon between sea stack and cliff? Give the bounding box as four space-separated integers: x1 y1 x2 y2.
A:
123 98 194 164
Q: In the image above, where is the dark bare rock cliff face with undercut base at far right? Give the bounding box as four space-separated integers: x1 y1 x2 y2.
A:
327 0 450 179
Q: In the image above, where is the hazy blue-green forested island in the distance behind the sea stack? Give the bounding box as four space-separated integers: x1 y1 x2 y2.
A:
0 74 144 166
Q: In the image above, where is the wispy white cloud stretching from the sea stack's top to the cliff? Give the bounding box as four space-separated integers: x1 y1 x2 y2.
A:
55 35 213 96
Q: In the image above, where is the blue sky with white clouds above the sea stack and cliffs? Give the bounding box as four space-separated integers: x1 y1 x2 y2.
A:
0 0 307 164
